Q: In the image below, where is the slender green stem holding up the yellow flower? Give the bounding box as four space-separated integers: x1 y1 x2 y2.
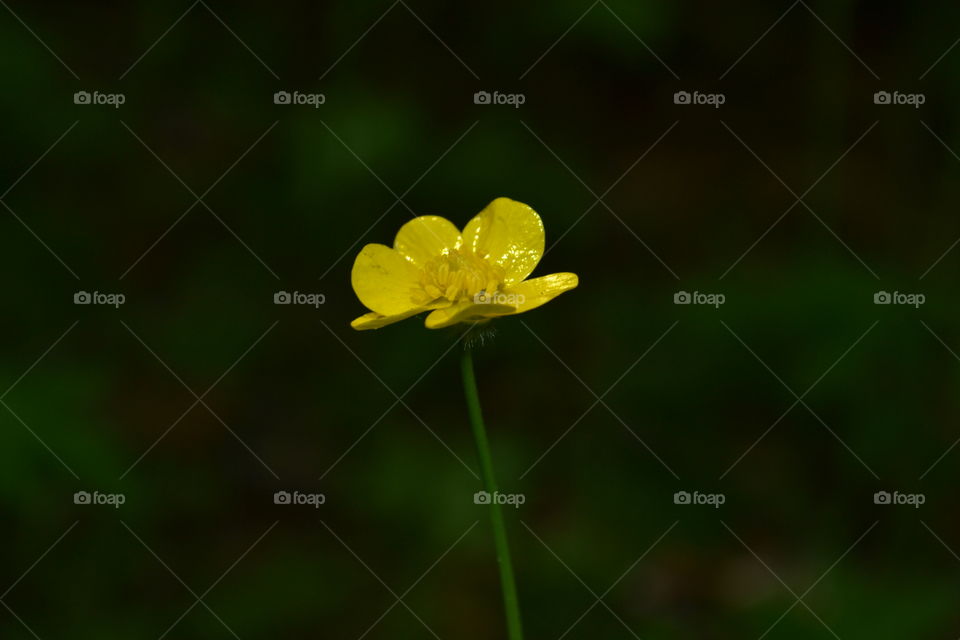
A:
460 346 523 640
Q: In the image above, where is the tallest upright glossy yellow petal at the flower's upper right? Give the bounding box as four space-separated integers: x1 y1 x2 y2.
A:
463 198 544 285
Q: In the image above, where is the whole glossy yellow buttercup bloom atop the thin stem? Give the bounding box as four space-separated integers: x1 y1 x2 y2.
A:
350 198 577 330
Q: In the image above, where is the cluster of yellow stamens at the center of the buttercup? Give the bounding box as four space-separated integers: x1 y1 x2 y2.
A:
413 248 505 304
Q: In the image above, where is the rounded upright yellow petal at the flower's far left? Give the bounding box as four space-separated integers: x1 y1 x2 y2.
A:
351 244 420 316
